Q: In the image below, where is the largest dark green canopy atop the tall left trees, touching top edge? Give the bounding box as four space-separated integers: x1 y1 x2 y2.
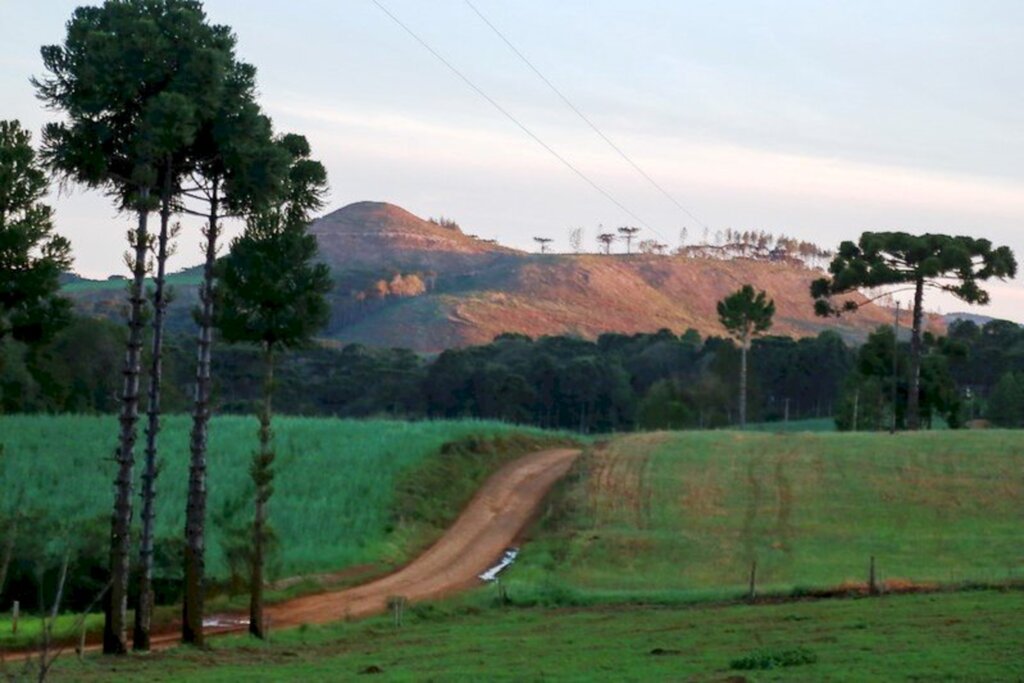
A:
33 0 234 209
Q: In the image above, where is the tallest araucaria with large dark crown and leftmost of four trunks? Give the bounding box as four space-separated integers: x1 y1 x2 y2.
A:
35 0 234 653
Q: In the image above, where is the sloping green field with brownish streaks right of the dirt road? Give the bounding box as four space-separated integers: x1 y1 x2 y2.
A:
507 431 1024 603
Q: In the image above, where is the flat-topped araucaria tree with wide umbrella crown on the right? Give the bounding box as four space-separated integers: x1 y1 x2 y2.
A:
811 232 1017 429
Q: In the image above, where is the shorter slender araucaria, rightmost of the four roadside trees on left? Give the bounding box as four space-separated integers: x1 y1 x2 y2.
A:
216 135 332 638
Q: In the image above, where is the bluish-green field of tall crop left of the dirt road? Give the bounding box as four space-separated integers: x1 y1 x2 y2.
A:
0 416 565 578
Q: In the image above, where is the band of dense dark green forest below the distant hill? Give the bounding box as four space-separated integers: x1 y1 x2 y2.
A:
0 317 1024 432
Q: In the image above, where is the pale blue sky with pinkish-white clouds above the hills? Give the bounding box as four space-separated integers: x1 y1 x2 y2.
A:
0 0 1024 322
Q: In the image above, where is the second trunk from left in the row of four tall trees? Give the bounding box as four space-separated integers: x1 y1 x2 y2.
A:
132 160 173 652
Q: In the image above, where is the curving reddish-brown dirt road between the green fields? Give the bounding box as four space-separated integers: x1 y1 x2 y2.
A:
8 449 580 661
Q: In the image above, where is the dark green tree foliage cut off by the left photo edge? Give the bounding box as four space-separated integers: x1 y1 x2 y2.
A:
0 121 71 342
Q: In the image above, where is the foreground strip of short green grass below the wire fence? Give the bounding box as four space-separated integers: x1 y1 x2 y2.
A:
34 591 1024 682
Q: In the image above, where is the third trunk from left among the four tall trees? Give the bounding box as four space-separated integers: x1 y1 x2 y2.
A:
181 179 220 647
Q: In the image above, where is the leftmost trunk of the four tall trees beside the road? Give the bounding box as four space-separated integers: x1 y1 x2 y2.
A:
103 194 150 654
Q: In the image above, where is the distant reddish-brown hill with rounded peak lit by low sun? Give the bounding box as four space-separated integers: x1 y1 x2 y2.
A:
67 202 890 351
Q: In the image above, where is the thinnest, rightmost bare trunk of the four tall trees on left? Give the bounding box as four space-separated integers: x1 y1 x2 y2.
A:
249 344 274 639
